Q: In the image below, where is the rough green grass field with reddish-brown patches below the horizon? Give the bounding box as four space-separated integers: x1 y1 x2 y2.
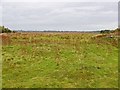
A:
2 32 118 88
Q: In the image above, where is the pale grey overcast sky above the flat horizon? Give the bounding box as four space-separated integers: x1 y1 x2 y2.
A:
2 2 118 31
